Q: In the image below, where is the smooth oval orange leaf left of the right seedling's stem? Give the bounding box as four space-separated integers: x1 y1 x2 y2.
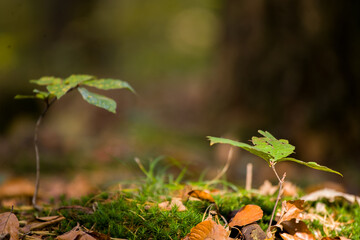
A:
229 204 263 227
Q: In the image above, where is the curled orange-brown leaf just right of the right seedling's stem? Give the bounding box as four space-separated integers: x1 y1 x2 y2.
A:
275 200 304 229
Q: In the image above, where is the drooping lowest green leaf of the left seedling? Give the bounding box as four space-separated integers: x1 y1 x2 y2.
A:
78 87 116 113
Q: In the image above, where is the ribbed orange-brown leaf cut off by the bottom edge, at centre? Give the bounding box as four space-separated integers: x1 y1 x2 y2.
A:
184 219 230 240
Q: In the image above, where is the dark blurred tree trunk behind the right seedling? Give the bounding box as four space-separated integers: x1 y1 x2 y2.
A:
211 0 360 179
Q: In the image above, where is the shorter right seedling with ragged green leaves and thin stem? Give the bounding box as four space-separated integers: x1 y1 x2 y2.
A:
208 130 342 237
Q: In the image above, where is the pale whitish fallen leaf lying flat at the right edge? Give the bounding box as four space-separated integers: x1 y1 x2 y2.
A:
301 188 360 205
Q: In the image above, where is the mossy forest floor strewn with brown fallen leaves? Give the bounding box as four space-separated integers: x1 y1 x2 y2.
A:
0 158 360 240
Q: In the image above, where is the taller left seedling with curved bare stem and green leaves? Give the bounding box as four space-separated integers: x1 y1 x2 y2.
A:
15 75 135 210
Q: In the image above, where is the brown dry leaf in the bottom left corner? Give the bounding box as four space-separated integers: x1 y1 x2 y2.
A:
0 212 19 240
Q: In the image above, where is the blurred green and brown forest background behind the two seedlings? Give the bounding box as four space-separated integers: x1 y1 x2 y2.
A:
0 0 360 193
